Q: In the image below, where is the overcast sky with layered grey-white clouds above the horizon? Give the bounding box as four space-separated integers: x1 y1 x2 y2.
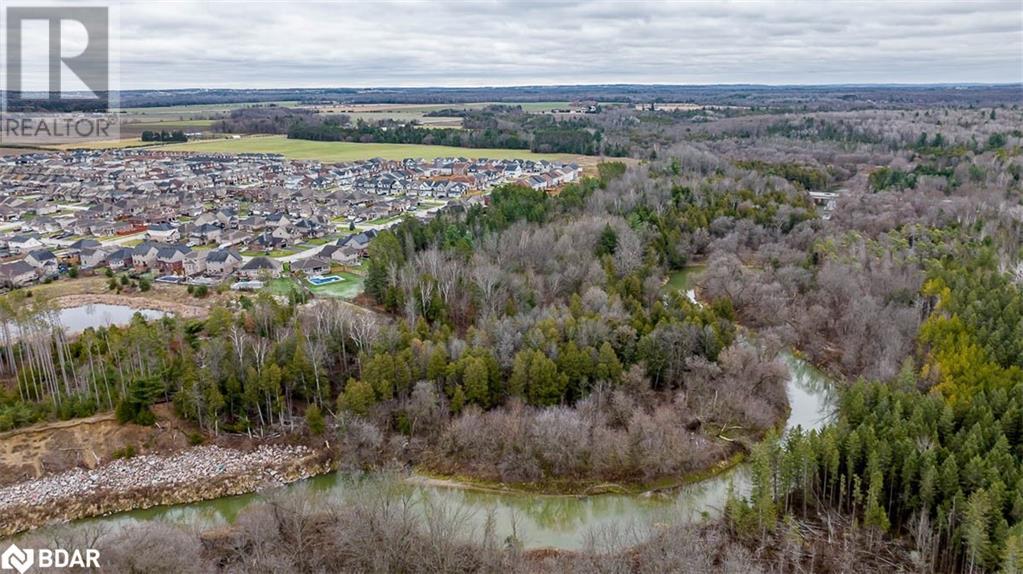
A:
18 0 1023 89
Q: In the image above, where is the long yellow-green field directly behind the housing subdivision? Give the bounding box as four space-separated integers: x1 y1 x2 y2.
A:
160 135 575 162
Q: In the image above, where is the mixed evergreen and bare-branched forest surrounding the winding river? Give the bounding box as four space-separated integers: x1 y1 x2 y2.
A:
7 98 1023 573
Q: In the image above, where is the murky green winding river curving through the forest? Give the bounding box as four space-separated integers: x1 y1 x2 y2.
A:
63 268 835 549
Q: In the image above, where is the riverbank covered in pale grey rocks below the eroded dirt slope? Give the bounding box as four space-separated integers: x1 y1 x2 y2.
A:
0 445 332 536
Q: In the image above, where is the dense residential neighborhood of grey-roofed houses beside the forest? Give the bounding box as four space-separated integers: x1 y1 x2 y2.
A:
0 148 581 288
